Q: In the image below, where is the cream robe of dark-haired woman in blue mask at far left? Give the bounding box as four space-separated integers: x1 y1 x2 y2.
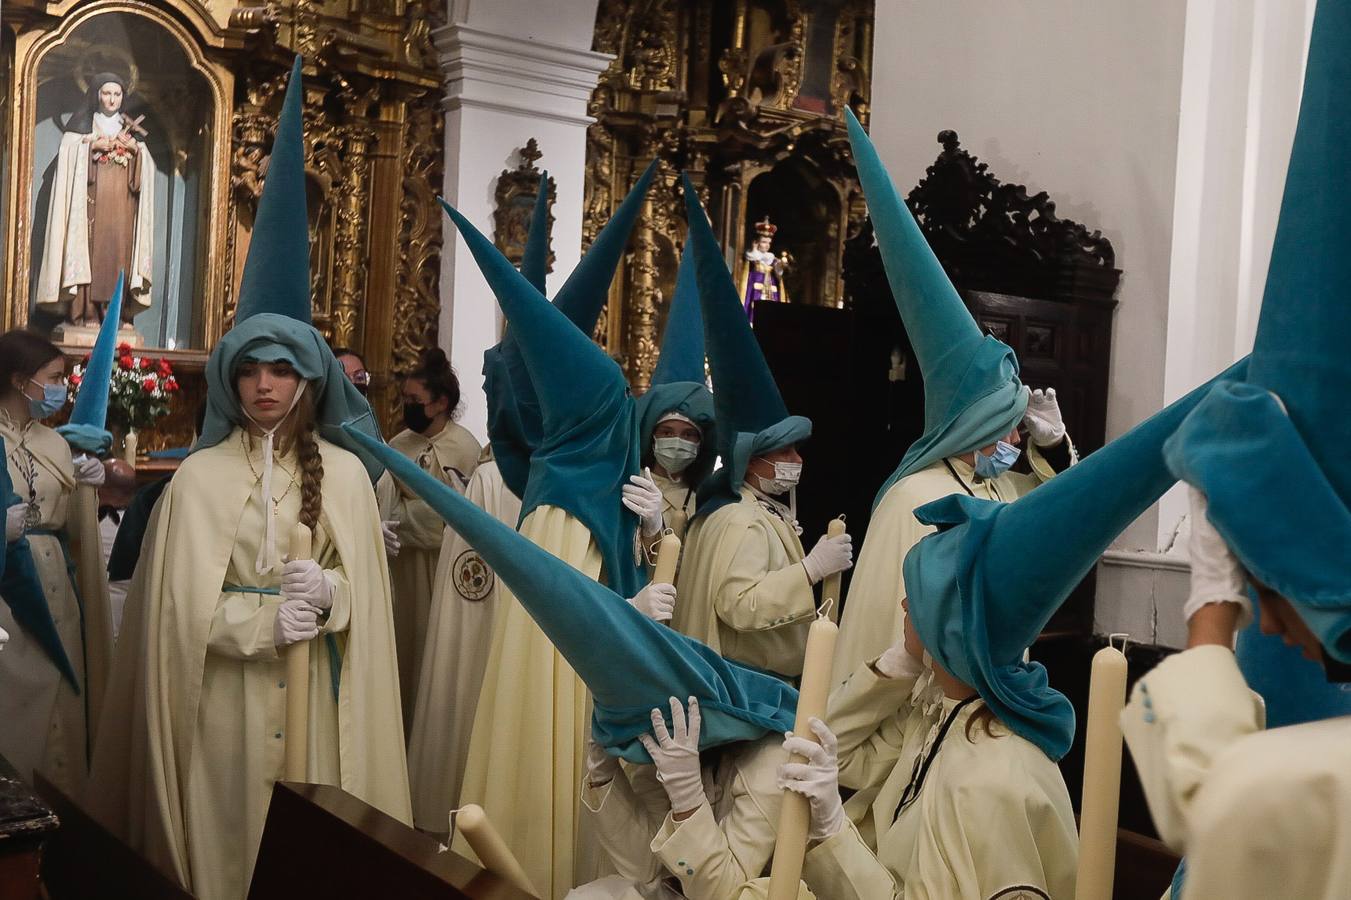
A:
0 412 112 796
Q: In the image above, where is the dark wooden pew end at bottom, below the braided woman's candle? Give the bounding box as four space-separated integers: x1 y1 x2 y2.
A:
249 782 530 900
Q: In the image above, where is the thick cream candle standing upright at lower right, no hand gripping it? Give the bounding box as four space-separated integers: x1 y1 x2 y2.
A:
1074 635 1125 900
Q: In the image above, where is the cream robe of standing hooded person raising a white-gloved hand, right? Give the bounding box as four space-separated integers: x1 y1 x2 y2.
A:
831 442 1077 684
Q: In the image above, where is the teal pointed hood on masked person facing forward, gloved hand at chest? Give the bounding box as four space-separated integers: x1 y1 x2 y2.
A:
638 242 717 489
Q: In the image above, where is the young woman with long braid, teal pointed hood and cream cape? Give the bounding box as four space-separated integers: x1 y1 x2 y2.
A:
91 58 412 900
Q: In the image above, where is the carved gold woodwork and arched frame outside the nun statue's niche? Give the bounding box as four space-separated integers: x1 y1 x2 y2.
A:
0 0 446 440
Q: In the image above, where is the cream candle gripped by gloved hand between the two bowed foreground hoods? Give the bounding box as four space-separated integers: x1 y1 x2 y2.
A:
769 605 840 900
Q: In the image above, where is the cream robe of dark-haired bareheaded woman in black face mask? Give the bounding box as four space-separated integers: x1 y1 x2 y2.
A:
377 422 482 728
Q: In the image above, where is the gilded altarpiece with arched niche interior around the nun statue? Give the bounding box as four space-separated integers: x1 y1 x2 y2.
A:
0 0 444 449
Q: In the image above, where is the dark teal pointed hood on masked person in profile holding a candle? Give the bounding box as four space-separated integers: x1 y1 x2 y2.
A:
685 176 812 516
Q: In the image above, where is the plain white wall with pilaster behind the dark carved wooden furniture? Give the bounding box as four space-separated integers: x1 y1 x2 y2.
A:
871 0 1315 643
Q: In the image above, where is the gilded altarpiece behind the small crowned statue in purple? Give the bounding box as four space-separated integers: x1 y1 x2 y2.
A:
582 0 873 389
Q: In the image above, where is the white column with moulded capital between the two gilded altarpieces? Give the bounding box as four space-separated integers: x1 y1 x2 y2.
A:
434 15 611 441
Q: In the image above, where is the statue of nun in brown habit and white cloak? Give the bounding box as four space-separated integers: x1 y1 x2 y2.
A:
36 72 155 327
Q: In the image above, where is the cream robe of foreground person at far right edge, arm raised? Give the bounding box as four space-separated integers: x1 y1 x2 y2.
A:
1121 645 1351 900
